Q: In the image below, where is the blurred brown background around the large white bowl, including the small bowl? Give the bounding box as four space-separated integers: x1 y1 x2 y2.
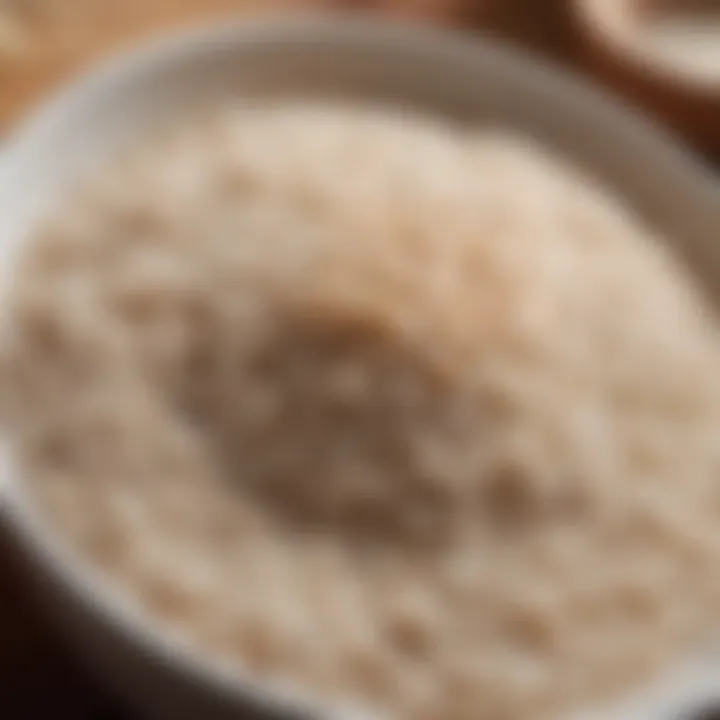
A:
0 0 720 720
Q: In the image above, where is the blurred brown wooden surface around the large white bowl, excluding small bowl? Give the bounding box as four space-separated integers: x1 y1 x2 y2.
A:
0 0 708 720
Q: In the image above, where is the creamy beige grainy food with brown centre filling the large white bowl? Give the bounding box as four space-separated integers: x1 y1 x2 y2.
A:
2 103 720 720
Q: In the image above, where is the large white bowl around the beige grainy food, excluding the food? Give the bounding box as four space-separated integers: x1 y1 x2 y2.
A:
0 17 720 720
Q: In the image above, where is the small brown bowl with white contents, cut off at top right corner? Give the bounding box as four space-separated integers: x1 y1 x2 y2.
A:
570 0 720 157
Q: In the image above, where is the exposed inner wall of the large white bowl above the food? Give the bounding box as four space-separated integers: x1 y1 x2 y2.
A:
0 19 720 720
